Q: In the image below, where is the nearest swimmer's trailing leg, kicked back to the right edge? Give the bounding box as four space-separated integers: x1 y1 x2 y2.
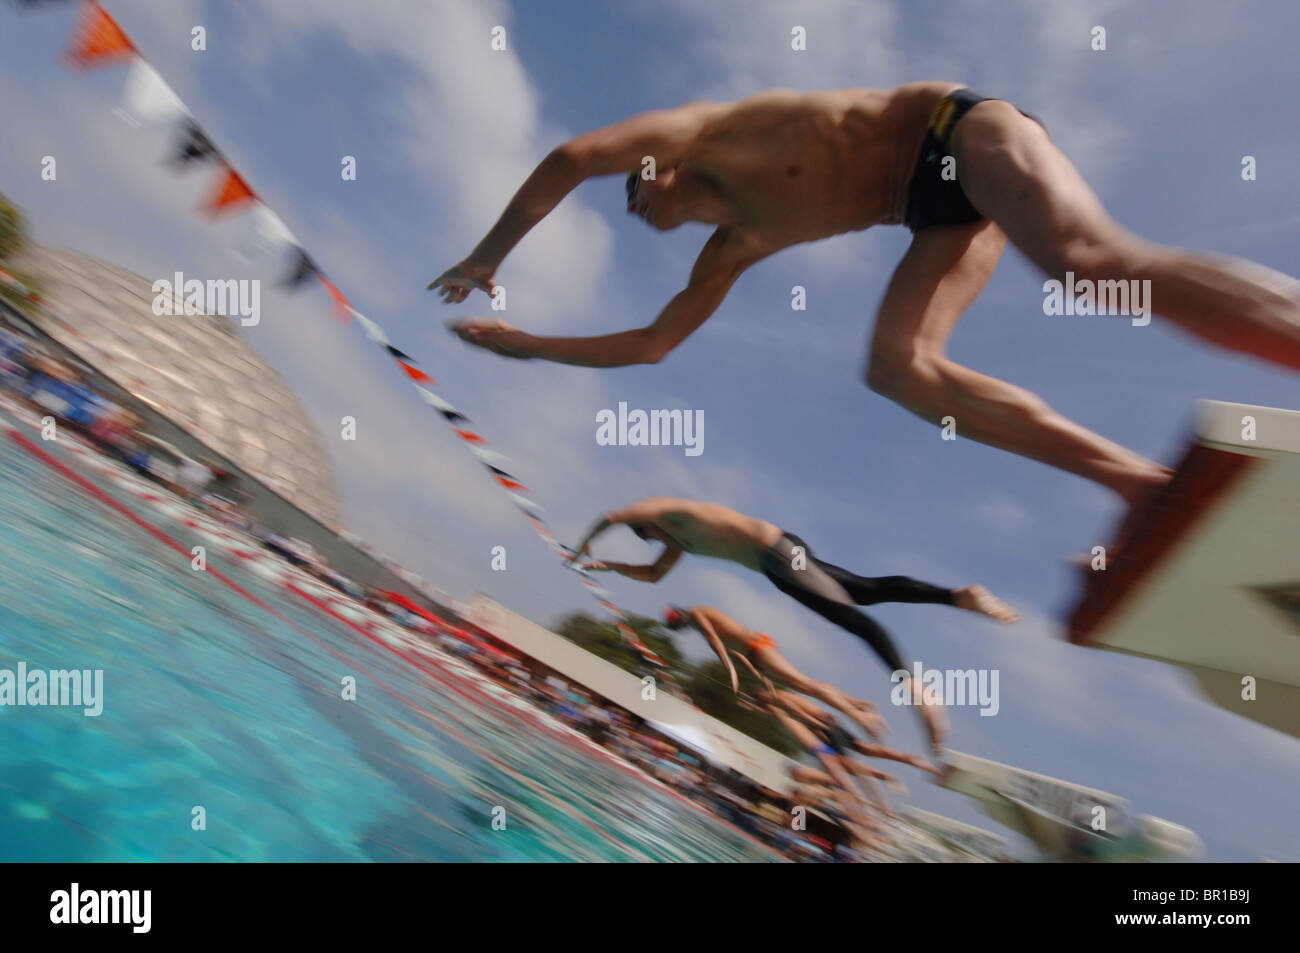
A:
953 101 1300 371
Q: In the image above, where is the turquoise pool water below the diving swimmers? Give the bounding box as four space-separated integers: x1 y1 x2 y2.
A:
0 410 775 861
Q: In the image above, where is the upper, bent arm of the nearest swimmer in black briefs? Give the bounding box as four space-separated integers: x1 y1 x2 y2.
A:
429 103 716 304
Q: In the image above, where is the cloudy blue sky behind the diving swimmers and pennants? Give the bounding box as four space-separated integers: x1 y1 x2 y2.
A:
0 0 1300 859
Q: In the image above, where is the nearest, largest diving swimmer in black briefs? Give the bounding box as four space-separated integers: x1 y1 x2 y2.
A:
429 82 1300 504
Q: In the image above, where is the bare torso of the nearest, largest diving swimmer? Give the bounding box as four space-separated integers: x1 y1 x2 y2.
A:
683 82 961 241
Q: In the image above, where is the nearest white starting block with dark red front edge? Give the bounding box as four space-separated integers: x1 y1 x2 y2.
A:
1069 400 1300 737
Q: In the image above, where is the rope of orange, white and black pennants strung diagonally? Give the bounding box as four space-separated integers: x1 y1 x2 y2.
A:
40 0 685 696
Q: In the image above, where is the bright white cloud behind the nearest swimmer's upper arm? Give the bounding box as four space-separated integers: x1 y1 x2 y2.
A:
239 0 611 326
